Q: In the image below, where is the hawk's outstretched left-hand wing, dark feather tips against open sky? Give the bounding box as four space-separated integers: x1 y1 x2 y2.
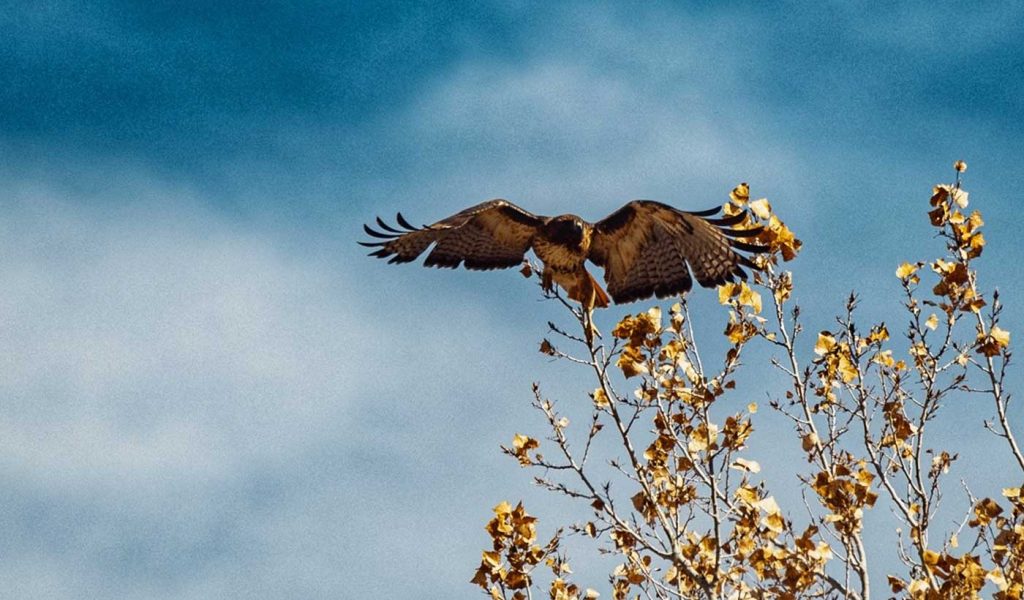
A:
359 200 545 270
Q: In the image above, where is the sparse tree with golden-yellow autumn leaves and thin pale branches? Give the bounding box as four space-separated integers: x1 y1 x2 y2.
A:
472 162 1024 600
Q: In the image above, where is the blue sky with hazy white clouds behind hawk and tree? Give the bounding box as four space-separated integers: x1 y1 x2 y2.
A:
6 1 1024 599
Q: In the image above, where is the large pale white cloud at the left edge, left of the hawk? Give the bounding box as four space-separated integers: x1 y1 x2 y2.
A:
0 176 382 598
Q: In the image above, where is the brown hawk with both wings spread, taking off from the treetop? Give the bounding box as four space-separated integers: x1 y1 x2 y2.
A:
359 200 768 311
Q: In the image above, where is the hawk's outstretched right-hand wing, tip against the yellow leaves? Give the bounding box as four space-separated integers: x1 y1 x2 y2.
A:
589 200 768 304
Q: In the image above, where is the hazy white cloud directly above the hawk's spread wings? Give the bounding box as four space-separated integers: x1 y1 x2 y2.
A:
319 6 814 220
